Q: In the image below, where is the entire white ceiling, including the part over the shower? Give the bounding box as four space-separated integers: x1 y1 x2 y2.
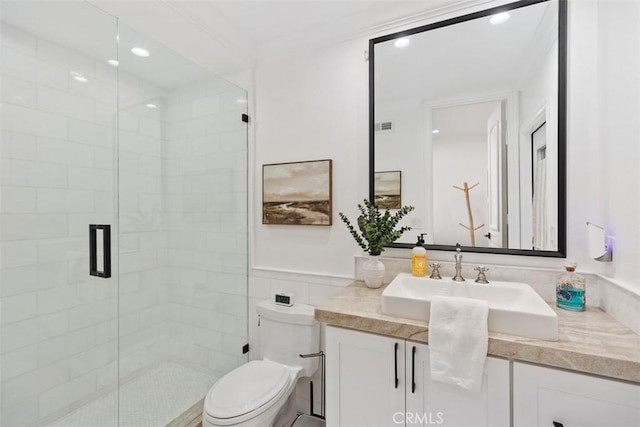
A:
2 0 476 86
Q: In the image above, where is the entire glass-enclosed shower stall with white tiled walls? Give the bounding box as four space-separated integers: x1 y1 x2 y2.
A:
0 1 248 427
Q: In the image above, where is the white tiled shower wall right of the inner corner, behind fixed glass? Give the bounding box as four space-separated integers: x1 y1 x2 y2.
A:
162 78 248 375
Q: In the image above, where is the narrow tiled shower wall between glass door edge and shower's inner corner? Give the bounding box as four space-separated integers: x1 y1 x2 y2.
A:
118 72 169 392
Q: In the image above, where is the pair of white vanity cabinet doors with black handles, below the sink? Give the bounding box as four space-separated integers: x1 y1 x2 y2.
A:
326 326 510 427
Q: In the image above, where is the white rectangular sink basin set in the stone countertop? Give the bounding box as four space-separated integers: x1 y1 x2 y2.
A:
382 273 558 341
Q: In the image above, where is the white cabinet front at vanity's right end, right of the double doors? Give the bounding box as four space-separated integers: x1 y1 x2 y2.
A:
513 362 640 427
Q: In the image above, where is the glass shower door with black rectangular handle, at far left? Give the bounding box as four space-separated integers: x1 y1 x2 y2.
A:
0 1 118 427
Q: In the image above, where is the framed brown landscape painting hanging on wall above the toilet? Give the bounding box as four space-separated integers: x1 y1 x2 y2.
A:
262 160 332 225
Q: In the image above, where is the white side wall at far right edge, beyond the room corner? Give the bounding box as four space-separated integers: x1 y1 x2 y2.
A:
596 1 640 291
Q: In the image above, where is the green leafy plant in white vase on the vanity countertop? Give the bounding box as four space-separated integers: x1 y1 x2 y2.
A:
340 199 414 288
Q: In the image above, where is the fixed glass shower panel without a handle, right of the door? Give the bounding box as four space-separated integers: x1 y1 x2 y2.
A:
118 23 248 427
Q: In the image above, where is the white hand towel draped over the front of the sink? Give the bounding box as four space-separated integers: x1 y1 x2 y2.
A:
429 296 489 392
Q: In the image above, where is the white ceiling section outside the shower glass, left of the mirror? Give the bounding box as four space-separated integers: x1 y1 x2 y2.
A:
90 0 469 75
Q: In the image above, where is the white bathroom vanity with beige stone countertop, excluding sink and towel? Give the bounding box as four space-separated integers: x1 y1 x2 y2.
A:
316 282 640 427
